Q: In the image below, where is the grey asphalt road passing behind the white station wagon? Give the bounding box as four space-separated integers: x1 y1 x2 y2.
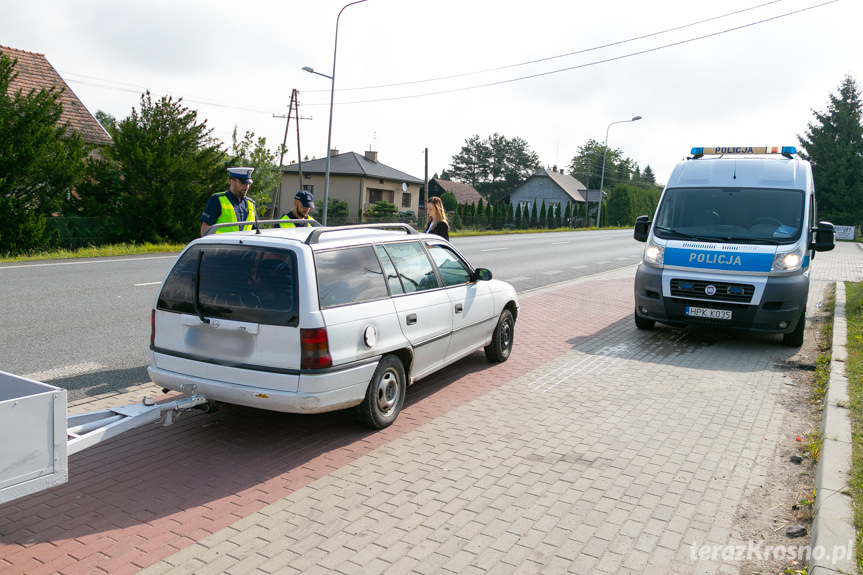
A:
0 230 643 400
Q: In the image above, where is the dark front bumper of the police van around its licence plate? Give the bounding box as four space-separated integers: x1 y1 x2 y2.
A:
635 263 809 333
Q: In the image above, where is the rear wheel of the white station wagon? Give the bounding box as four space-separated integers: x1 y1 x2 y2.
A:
356 355 407 429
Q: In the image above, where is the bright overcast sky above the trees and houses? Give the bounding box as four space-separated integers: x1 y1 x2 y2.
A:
0 0 863 187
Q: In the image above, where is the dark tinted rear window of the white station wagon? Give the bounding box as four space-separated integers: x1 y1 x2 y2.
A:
156 245 298 326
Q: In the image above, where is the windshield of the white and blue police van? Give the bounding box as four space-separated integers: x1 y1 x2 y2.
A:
653 188 804 244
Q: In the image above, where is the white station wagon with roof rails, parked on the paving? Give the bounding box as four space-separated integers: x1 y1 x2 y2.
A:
148 221 519 428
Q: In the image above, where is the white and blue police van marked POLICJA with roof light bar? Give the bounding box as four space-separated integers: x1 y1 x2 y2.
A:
634 146 834 347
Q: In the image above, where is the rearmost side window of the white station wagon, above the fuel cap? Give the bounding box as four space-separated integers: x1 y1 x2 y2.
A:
315 246 389 309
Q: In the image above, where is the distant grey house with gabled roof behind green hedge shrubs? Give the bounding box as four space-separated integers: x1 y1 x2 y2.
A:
509 166 599 223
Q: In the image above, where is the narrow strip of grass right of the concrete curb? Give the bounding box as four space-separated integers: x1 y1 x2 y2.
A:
845 282 863 572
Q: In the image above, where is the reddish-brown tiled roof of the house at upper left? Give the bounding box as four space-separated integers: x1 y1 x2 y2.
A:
0 46 111 146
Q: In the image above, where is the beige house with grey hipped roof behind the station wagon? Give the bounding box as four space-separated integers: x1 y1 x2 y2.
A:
276 150 425 222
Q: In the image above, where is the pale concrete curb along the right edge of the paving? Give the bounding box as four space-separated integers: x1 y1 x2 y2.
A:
809 281 857 575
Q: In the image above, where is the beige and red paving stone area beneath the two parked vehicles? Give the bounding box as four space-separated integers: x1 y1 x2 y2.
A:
0 244 863 575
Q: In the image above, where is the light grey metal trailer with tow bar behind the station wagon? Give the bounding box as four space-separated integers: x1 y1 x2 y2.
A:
0 371 207 503
